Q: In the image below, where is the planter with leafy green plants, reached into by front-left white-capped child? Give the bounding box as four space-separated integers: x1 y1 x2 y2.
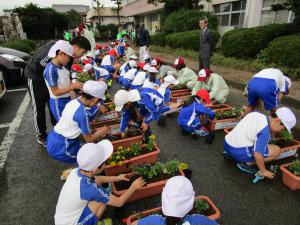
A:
112 160 188 202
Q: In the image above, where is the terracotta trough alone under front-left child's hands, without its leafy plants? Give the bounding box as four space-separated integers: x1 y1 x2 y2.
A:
112 171 184 202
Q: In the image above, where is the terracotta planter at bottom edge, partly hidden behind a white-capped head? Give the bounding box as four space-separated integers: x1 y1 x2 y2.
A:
126 196 221 225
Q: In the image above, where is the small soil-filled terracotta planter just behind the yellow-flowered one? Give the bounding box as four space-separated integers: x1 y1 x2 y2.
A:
107 129 144 151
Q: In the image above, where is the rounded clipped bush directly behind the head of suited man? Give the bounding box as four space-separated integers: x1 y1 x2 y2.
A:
162 9 218 34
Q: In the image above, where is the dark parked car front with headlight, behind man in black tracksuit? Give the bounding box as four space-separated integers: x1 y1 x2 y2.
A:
0 47 31 85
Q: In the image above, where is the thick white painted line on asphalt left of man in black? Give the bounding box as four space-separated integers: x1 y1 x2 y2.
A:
0 92 30 169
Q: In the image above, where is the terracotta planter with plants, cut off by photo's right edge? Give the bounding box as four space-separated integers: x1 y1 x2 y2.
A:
280 160 300 191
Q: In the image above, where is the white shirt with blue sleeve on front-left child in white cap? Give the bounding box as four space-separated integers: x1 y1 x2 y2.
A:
54 168 109 225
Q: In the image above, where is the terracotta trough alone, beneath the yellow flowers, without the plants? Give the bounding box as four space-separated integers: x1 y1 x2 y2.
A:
104 145 160 176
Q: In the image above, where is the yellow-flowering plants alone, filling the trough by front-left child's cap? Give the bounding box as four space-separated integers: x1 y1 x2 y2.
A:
106 135 155 166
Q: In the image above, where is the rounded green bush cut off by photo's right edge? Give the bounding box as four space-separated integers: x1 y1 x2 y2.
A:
258 34 300 69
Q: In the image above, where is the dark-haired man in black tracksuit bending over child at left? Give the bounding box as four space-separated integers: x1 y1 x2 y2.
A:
24 36 91 147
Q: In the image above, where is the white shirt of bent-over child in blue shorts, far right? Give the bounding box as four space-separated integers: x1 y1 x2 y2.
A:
253 68 285 92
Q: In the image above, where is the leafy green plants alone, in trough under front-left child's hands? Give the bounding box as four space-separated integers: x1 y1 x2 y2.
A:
132 160 188 181
